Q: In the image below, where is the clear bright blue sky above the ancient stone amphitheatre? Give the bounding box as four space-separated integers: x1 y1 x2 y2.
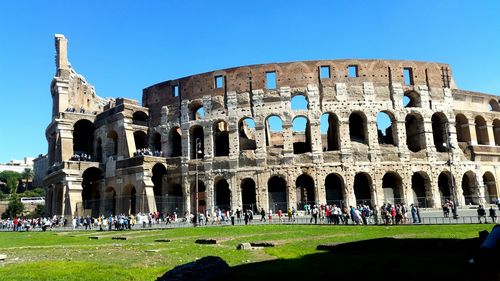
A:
0 0 500 162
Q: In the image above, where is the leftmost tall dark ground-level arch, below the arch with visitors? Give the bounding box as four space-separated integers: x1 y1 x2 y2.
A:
81 167 104 217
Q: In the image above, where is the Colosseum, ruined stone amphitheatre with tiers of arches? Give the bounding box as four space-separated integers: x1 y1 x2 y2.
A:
44 35 500 216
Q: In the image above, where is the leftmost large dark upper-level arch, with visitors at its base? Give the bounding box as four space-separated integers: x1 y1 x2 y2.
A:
72 119 95 160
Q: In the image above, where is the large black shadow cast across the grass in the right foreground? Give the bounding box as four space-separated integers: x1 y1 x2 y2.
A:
228 238 479 281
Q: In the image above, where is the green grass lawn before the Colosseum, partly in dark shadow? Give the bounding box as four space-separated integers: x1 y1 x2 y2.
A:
0 225 492 281
